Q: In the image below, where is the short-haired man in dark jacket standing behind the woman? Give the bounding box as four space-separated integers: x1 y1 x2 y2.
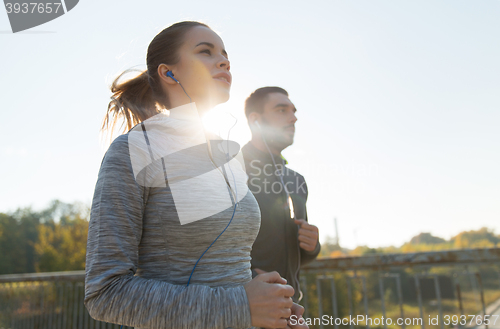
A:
242 87 321 301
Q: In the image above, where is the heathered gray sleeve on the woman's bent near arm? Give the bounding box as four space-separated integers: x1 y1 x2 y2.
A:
84 135 251 329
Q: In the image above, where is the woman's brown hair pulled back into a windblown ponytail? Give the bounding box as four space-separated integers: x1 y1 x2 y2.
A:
101 21 210 142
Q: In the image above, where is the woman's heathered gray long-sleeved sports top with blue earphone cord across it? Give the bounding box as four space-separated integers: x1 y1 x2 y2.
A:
85 103 260 329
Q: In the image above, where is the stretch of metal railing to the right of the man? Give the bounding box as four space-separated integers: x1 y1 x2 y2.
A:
301 248 500 329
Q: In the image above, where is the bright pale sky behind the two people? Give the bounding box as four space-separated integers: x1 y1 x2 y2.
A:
0 0 500 248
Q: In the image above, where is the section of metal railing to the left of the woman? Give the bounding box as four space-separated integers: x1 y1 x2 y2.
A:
0 271 129 329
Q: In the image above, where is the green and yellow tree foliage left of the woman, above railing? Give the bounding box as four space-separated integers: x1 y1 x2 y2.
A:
0 200 89 274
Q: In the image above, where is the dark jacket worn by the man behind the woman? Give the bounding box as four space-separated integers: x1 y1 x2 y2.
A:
242 142 321 301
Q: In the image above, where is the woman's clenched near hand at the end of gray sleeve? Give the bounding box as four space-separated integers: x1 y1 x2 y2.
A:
244 271 294 328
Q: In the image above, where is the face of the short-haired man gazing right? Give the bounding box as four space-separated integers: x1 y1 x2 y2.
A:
261 93 297 149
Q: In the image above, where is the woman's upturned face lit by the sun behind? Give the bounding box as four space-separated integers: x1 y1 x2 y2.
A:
169 26 232 108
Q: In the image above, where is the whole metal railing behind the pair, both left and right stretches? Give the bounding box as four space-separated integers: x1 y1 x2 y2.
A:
0 248 500 329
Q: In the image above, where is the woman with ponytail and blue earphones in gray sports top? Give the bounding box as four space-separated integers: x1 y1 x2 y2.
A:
85 22 303 329
